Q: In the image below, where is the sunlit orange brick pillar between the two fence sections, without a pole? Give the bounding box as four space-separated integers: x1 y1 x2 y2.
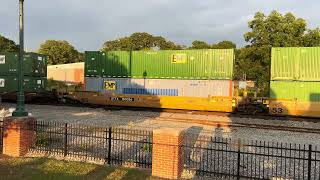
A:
152 128 183 179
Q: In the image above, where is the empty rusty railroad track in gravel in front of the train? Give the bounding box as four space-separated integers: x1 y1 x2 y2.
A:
2 103 320 134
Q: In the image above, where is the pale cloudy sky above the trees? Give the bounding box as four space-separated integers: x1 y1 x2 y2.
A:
0 0 320 51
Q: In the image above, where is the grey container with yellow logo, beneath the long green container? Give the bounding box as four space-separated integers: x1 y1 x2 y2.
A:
97 78 233 97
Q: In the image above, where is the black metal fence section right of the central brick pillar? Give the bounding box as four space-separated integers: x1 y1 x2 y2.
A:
182 136 320 180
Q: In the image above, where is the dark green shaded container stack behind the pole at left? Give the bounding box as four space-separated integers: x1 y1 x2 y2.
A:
0 53 47 93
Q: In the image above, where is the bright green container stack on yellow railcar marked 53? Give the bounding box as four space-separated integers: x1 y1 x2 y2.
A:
270 47 320 117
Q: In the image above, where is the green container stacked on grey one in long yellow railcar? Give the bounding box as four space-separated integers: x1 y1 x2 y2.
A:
81 49 234 112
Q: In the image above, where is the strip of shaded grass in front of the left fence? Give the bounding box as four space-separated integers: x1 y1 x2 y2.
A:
0 157 151 180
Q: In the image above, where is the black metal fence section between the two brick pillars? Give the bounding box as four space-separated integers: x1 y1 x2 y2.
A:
31 121 152 168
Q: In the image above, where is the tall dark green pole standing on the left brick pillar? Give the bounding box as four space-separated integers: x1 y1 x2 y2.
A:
12 0 28 117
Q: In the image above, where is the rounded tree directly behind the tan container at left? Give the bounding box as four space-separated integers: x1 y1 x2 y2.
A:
39 40 83 65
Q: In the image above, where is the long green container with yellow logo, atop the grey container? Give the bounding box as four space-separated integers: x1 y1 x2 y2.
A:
85 49 234 79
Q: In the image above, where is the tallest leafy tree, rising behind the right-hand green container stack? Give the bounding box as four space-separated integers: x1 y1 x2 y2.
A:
235 11 320 95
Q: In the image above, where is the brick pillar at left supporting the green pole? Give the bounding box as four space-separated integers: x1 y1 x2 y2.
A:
3 117 36 157
